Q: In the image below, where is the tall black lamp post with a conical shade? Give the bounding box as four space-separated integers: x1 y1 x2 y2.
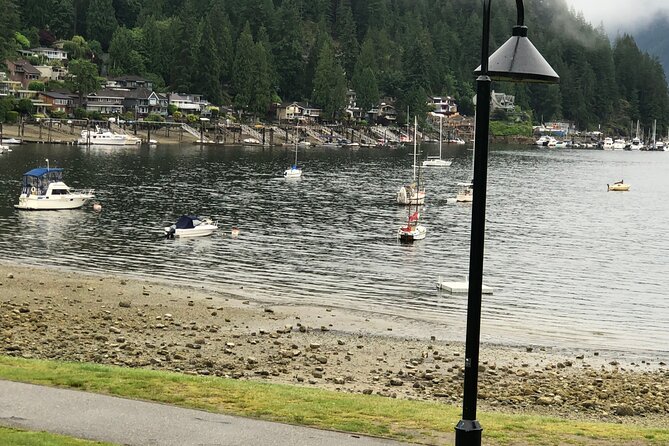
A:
455 0 560 446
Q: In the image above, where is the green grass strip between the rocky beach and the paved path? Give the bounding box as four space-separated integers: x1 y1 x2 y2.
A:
0 356 669 446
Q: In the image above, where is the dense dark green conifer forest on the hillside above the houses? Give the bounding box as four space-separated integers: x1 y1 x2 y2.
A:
0 0 669 133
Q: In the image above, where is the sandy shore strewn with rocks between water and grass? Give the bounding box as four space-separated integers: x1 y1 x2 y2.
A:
0 264 669 426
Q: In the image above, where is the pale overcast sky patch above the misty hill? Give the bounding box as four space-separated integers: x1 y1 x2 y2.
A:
566 0 669 33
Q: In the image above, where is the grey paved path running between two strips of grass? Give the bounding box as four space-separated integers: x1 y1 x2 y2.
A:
0 380 410 446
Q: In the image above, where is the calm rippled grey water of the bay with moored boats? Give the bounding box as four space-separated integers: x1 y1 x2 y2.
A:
0 145 669 355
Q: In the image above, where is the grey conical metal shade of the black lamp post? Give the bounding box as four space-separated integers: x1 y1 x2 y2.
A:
474 26 560 84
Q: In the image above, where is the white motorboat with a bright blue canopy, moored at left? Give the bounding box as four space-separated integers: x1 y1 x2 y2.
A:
14 161 95 211
